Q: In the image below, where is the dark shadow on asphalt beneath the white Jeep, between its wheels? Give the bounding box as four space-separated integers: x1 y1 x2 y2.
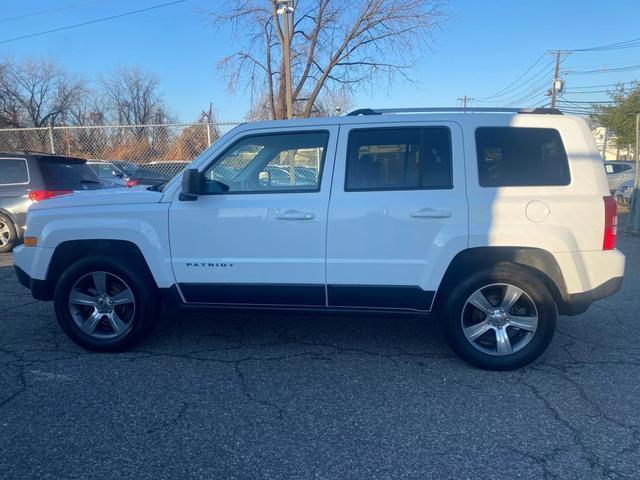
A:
149 310 456 359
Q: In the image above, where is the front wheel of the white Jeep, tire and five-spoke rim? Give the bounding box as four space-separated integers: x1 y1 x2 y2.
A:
54 256 160 352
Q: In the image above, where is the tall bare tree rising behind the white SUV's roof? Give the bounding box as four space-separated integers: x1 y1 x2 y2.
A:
211 0 446 119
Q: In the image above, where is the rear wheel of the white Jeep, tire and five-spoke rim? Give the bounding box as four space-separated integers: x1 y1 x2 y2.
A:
442 264 558 370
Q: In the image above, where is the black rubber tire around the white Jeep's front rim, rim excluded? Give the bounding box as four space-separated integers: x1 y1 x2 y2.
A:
54 256 158 351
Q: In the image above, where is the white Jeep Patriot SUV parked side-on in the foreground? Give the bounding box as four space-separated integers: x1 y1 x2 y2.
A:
15 109 624 370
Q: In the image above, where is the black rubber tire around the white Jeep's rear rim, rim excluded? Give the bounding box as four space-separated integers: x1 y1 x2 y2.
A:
442 267 558 370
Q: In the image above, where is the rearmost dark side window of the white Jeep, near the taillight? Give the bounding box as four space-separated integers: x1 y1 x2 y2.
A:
476 127 571 187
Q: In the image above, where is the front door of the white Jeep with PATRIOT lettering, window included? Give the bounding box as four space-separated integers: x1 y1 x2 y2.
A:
169 127 338 307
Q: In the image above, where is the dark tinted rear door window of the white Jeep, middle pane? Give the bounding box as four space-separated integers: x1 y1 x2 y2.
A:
345 127 452 191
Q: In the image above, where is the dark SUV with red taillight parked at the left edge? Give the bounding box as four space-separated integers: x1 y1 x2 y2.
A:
0 152 104 253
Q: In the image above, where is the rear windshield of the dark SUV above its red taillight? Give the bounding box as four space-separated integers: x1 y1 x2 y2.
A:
40 160 103 190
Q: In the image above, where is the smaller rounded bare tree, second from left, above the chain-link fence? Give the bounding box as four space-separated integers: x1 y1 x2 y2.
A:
100 67 169 125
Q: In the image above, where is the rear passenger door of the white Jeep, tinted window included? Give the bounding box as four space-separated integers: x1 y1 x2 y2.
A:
327 122 468 311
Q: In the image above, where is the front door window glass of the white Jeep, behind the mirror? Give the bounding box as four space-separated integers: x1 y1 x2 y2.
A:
205 132 329 193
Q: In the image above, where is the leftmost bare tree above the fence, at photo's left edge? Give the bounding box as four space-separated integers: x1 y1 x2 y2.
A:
0 59 84 127
